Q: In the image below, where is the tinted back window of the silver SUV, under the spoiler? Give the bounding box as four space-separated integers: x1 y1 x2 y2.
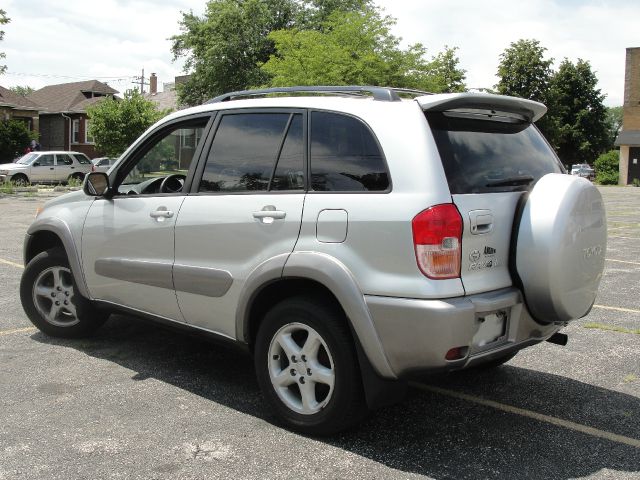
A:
426 112 563 194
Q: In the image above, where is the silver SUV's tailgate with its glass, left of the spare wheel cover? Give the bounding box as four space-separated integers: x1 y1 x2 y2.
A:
426 105 561 294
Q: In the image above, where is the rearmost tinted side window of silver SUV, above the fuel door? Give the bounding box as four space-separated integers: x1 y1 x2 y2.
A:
311 112 389 192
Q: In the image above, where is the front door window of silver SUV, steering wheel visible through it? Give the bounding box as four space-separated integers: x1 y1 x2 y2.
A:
117 118 208 194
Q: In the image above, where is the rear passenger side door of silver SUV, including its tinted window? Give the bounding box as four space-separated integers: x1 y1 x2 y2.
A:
173 110 306 338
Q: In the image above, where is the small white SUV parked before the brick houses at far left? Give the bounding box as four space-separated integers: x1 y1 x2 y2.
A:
0 151 91 185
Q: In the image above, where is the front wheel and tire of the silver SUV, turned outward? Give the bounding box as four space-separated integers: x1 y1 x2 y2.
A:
20 248 108 338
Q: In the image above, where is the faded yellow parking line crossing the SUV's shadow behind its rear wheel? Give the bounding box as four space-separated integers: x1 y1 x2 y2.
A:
410 382 640 448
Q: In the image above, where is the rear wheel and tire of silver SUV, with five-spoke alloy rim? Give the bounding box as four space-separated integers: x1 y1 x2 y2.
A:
254 297 367 435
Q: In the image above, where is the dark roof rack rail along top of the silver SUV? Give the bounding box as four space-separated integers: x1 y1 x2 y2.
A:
207 85 431 103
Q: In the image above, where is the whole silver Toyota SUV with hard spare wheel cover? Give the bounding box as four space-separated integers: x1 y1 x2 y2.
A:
20 87 606 434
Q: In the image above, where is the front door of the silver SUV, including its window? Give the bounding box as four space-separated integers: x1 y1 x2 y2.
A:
82 117 208 321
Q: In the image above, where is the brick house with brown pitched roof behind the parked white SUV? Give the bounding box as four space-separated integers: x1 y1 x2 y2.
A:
28 80 118 158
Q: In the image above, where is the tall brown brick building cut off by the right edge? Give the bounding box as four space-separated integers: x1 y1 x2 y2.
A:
615 47 640 185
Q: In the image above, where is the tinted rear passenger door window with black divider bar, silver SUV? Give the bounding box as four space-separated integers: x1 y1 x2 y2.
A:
199 113 303 192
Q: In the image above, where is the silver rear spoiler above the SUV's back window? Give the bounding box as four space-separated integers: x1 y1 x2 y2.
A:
415 93 547 122
